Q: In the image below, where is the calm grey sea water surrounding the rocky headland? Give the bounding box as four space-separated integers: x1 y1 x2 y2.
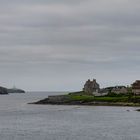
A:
0 92 140 140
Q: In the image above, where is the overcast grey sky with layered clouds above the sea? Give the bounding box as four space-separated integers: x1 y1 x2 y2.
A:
0 0 140 91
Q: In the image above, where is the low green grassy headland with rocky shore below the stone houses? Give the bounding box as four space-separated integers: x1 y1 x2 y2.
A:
35 91 140 106
